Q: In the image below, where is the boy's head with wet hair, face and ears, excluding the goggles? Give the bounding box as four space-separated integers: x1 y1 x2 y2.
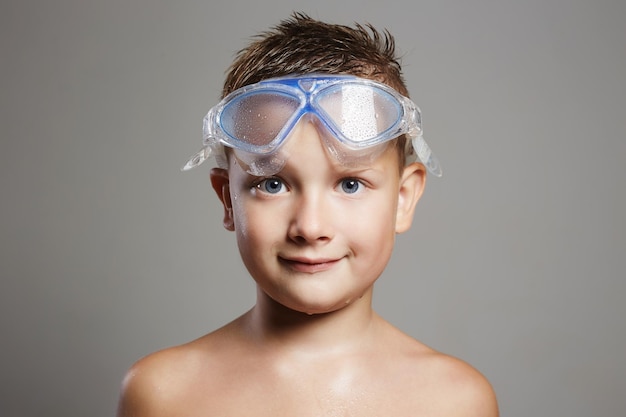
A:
206 14 426 314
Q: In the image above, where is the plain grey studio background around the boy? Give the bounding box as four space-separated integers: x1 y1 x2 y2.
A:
0 0 626 417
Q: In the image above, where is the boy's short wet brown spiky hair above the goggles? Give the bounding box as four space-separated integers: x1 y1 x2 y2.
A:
222 13 408 167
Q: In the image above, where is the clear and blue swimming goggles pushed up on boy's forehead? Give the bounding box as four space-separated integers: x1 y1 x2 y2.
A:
182 74 442 177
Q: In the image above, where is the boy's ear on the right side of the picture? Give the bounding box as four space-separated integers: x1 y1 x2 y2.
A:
396 162 426 233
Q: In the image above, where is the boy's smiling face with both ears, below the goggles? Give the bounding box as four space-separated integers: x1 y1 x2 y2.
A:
211 120 425 314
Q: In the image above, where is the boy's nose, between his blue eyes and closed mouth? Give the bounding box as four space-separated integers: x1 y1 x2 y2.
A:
289 190 334 244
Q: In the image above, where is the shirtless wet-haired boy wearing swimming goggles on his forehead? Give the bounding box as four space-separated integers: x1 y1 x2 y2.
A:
118 14 498 417
